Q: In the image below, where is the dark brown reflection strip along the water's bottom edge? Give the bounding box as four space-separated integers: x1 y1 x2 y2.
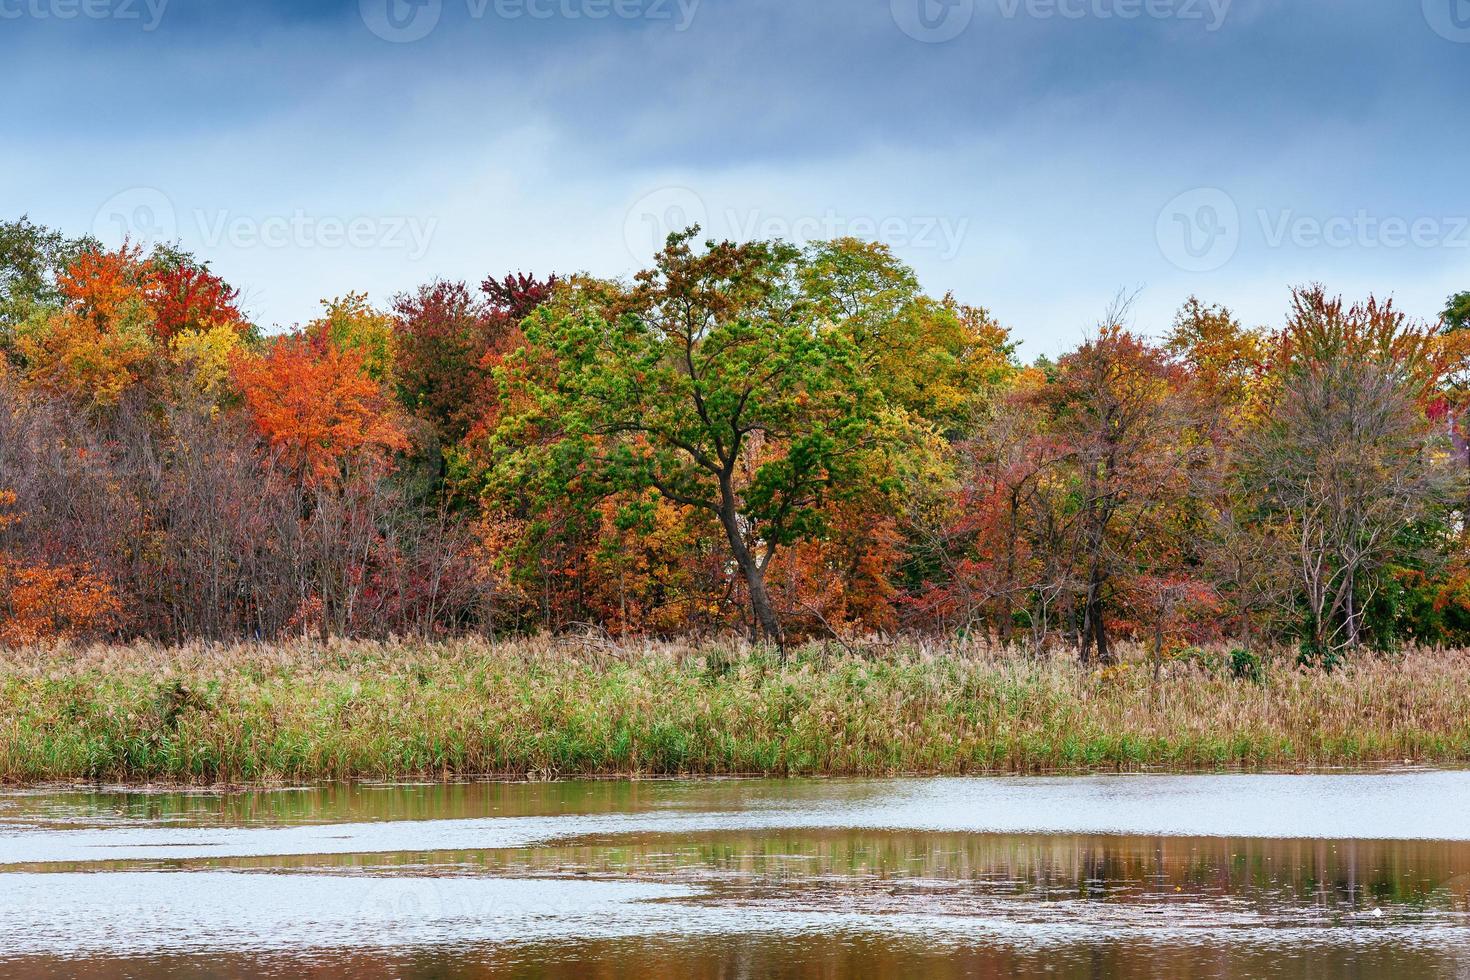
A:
4 932 1470 980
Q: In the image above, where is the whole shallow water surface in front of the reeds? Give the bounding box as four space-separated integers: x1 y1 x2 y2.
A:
0 771 1470 979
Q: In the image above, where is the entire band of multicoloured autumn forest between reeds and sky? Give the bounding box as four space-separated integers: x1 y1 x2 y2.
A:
0 217 1470 667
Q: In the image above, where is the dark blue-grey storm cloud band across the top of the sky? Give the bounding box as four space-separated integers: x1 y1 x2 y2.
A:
11 0 1470 165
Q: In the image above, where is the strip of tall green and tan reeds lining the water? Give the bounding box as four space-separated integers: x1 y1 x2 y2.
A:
0 639 1470 783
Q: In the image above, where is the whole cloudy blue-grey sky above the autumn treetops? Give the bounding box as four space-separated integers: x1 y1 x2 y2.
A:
0 0 1470 357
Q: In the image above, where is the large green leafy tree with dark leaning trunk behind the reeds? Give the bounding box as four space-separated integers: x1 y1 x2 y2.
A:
492 229 894 644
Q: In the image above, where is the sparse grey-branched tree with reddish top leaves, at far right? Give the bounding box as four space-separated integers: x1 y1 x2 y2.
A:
1244 287 1458 664
